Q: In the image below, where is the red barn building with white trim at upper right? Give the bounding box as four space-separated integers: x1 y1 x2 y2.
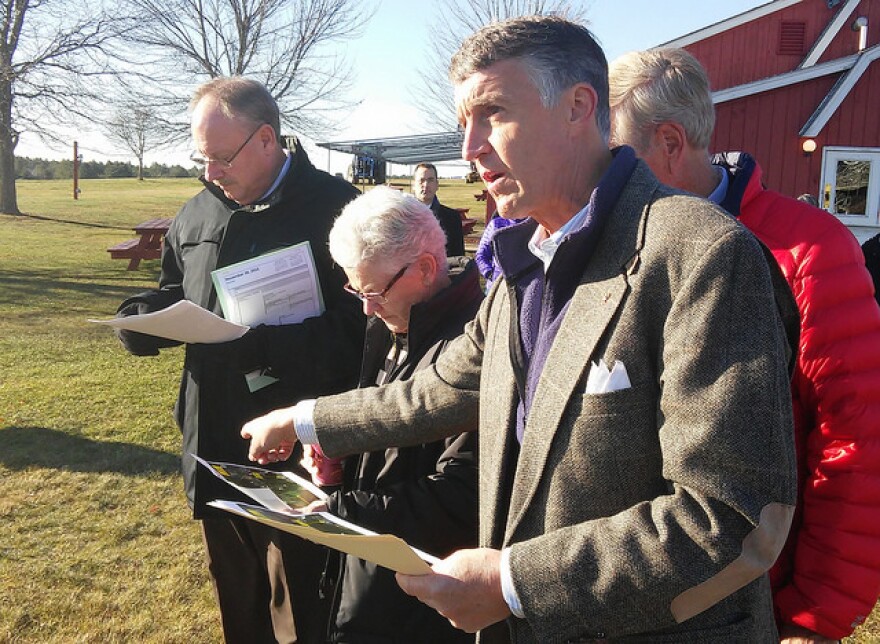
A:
663 0 880 242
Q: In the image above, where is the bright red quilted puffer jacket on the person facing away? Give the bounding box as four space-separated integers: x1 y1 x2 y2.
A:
714 153 880 639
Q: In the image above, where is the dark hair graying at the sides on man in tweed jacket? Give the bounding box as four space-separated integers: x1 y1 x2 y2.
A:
449 16 610 141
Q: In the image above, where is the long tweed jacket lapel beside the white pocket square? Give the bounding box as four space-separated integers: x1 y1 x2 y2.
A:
504 162 659 543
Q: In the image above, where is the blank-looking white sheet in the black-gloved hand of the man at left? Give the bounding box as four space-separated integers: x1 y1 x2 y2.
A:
89 300 248 343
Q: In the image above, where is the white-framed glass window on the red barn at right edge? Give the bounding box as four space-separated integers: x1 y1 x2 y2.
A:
821 147 880 227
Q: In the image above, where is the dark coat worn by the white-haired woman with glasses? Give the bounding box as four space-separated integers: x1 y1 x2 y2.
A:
329 257 482 644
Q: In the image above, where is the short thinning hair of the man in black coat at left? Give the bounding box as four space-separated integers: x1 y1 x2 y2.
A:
189 76 281 142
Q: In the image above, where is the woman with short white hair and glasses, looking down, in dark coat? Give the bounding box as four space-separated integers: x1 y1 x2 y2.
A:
296 186 483 644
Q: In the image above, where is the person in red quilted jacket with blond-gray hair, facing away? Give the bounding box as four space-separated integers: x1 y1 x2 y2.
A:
610 49 880 642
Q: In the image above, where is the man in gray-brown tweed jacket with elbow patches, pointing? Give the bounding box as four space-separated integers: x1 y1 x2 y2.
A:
242 17 796 644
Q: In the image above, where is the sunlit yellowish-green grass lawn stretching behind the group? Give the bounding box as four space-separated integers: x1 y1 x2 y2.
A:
0 179 880 643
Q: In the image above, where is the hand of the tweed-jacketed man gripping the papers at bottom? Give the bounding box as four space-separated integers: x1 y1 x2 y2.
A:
396 548 510 633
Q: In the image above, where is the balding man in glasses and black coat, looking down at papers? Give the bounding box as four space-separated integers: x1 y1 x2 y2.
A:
118 77 364 642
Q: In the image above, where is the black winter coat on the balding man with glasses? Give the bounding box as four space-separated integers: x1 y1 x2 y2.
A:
120 145 363 518
